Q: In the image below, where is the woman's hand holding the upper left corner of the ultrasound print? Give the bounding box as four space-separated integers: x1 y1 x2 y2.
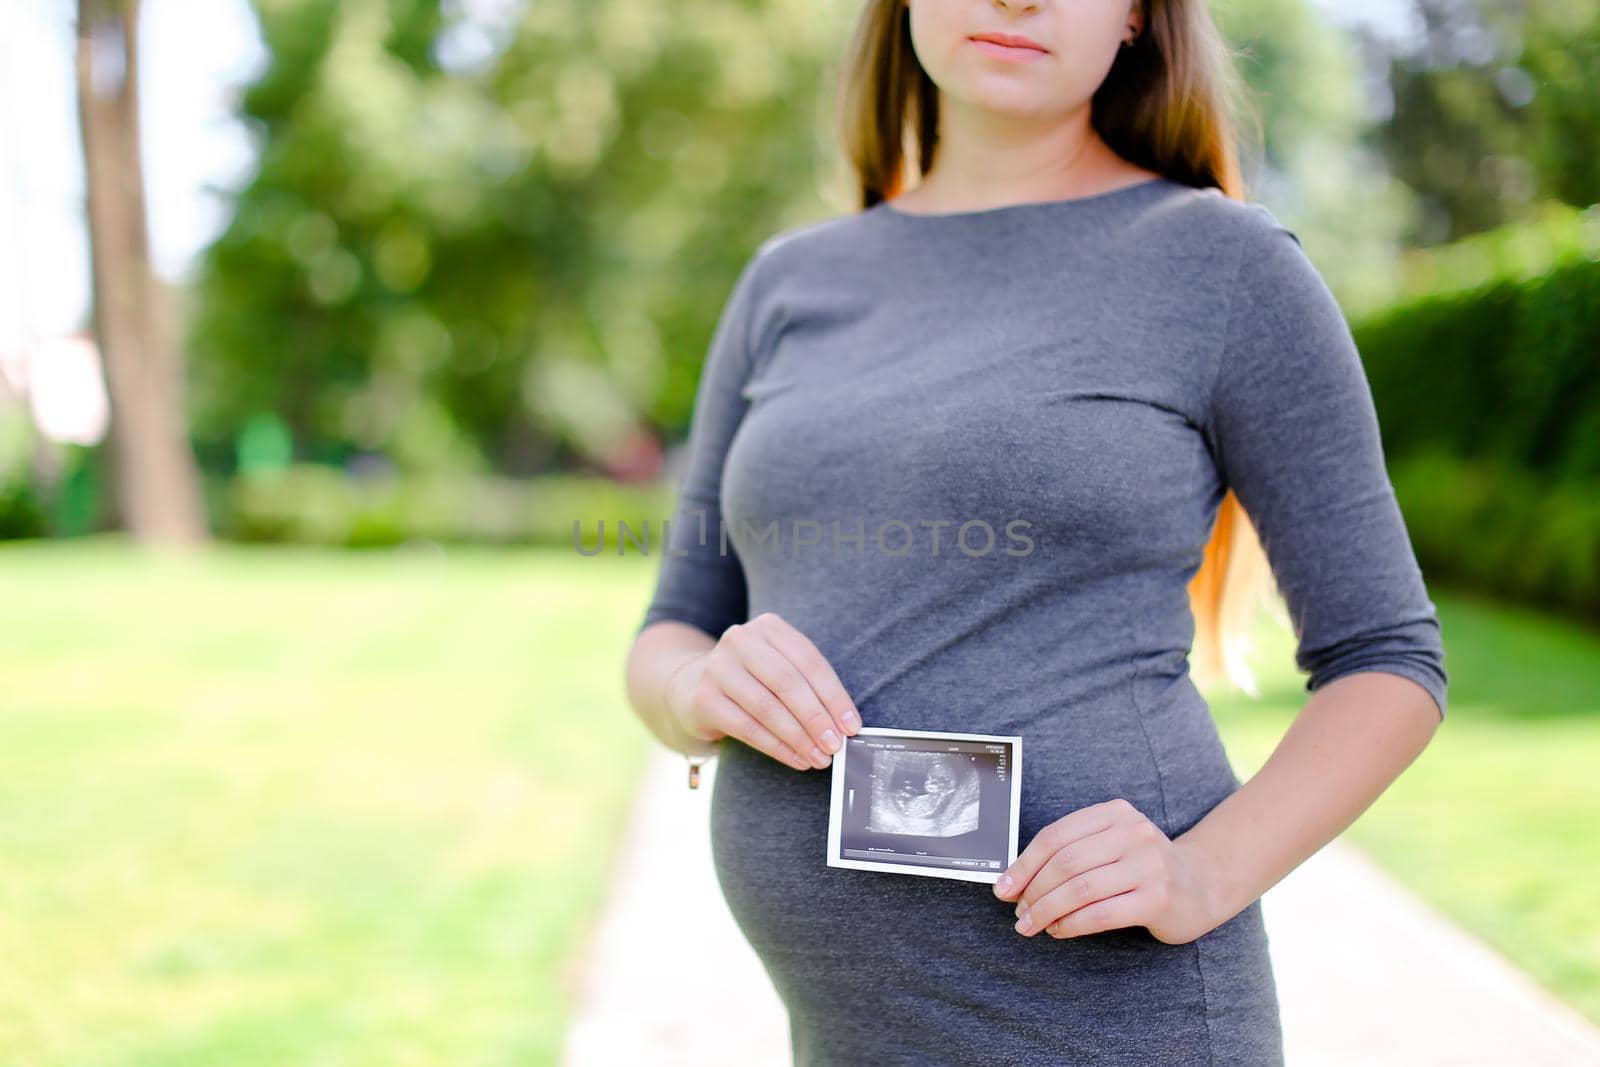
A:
667 611 861 771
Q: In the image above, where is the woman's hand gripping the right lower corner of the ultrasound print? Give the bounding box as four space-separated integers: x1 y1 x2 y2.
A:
995 797 1218 945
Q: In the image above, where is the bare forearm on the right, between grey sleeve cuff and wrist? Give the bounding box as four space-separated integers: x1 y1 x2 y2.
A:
1173 669 1440 926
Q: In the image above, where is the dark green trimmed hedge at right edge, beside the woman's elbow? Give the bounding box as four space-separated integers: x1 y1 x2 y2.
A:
1352 208 1600 619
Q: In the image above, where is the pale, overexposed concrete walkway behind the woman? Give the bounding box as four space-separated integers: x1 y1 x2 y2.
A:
565 747 1600 1067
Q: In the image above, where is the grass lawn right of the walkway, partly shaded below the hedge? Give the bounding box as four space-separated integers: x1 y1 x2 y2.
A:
1211 589 1600 1022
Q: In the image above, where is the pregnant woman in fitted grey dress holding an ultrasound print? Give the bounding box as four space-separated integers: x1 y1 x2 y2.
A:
627 0 1446 1067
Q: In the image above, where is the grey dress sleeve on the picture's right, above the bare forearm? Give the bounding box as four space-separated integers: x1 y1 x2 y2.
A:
1208 205 1448 718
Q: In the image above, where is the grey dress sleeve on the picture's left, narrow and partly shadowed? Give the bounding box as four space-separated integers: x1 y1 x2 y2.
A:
638 242 771 637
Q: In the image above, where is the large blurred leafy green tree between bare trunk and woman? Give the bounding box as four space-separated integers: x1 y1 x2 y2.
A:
190 0 843 474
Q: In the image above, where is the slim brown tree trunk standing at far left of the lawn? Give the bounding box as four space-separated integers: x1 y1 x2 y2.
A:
77 0 208 544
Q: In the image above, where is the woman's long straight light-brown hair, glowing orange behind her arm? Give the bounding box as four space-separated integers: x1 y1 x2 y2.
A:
838 0 1282 693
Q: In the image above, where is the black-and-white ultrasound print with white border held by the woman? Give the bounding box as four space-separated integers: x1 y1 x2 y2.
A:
827 726 1022 883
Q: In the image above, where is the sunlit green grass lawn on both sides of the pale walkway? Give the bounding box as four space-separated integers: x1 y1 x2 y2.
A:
0 541 1600 1067
